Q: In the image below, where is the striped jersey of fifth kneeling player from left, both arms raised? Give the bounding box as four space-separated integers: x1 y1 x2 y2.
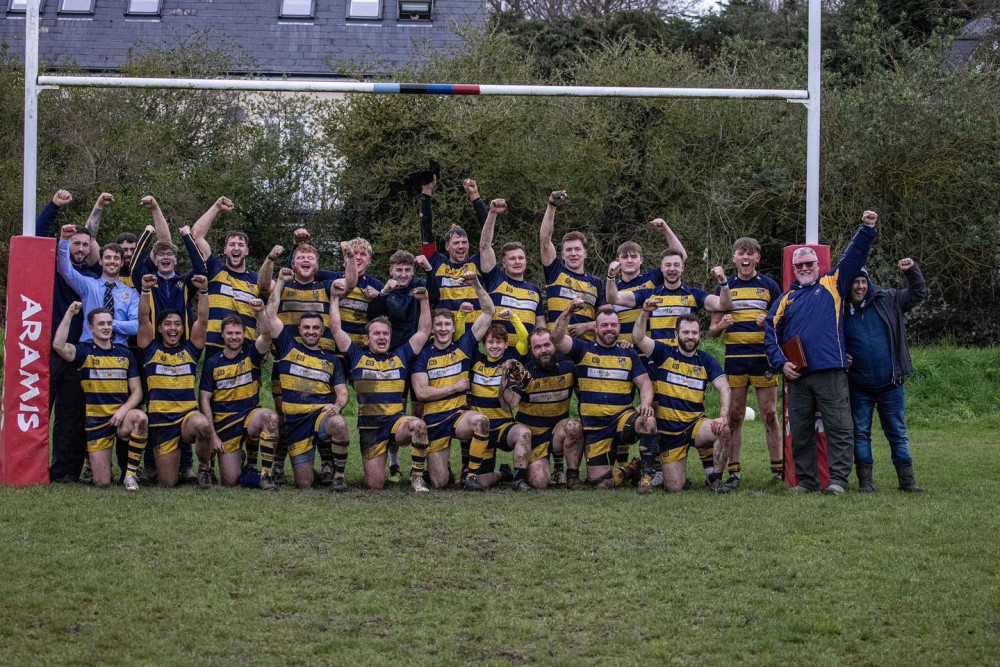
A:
344 343 413 429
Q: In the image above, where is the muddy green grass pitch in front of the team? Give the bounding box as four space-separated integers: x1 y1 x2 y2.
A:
0 348 1000 665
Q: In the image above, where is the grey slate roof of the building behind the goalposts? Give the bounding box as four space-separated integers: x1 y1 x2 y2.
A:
0 0 484 78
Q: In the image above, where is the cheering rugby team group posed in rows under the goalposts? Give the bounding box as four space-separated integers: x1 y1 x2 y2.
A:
36 170 928 494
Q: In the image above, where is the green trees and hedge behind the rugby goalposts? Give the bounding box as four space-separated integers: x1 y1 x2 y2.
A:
0 0 1000 344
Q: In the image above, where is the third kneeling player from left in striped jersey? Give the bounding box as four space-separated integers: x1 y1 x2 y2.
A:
201 299 278 491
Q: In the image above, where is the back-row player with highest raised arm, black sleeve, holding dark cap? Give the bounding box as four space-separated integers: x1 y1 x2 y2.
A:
420 168 493 320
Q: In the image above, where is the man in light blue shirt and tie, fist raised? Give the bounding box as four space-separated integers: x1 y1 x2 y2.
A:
56 225 139 345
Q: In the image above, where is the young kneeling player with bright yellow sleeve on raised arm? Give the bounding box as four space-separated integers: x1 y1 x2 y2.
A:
465 308 531 491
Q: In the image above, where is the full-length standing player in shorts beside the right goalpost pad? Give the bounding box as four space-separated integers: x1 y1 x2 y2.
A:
708 237 785 489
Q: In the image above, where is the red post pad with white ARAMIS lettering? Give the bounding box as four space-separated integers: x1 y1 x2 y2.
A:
0 236 56 486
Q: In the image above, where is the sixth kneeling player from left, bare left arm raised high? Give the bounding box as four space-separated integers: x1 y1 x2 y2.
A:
412 271 494 491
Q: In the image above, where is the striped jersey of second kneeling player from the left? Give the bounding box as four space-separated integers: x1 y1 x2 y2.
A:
142 340 201 426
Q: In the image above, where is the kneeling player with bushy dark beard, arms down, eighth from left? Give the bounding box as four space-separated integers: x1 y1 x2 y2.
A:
500 327 583 491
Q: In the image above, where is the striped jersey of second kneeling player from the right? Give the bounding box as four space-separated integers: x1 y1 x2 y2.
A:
567 338 648 428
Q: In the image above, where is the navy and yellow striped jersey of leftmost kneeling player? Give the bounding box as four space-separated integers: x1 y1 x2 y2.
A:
73 341 139 429
